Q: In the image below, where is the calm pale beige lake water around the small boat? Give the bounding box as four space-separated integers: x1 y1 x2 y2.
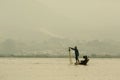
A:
0 58 120 80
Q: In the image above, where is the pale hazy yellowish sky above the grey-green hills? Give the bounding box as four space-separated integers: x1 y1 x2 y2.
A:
0 0 120 41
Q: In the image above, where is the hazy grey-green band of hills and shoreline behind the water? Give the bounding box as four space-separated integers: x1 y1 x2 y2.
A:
0 39 120 58
